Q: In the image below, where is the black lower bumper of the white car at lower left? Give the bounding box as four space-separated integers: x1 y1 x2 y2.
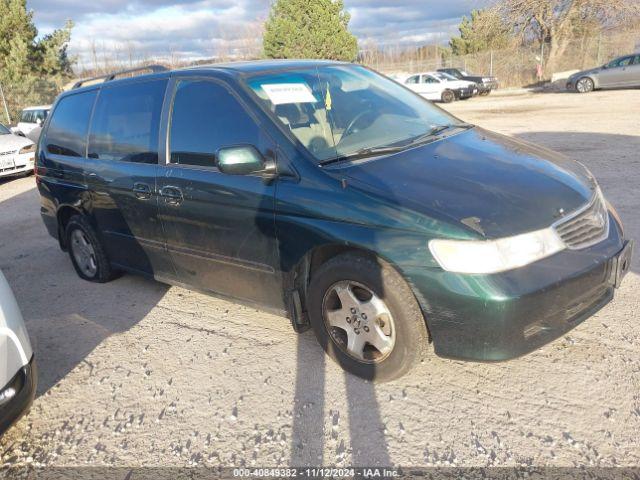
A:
0 357 38 435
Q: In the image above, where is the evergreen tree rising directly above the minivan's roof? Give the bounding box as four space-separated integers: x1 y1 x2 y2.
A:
264 0 358 61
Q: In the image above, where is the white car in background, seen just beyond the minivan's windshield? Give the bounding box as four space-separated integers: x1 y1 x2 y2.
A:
404 72 478 103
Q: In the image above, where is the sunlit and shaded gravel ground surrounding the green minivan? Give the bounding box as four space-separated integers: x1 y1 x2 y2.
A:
0 90 640 466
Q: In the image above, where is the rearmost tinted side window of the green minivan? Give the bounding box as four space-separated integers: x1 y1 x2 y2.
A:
46 90 97 157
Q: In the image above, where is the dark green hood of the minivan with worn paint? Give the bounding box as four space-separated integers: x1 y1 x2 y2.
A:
332 127 596 238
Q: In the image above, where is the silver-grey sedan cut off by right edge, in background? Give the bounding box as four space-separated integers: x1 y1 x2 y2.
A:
567 53 640 93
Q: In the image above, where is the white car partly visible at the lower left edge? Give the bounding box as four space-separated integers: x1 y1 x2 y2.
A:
0 271 37 435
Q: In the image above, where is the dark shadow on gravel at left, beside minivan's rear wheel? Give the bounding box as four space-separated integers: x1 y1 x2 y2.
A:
0 189 169 396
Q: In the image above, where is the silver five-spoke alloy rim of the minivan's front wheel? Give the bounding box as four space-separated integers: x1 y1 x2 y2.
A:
322 280 396 363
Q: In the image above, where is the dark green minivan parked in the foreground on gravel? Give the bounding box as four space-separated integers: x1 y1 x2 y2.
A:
36 61 631 380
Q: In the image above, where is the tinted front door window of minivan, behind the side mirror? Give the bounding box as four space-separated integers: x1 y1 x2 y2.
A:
169 80 261 167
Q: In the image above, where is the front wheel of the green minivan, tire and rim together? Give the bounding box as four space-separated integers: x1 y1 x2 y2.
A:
307 253 428 382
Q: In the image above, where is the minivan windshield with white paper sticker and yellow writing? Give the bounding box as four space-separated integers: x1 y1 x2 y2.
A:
247 65 462 163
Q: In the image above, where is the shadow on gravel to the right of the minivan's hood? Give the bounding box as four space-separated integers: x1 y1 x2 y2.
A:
516 132 640 273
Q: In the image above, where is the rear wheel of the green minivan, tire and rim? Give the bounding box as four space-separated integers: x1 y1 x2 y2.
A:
65 215 117 283
